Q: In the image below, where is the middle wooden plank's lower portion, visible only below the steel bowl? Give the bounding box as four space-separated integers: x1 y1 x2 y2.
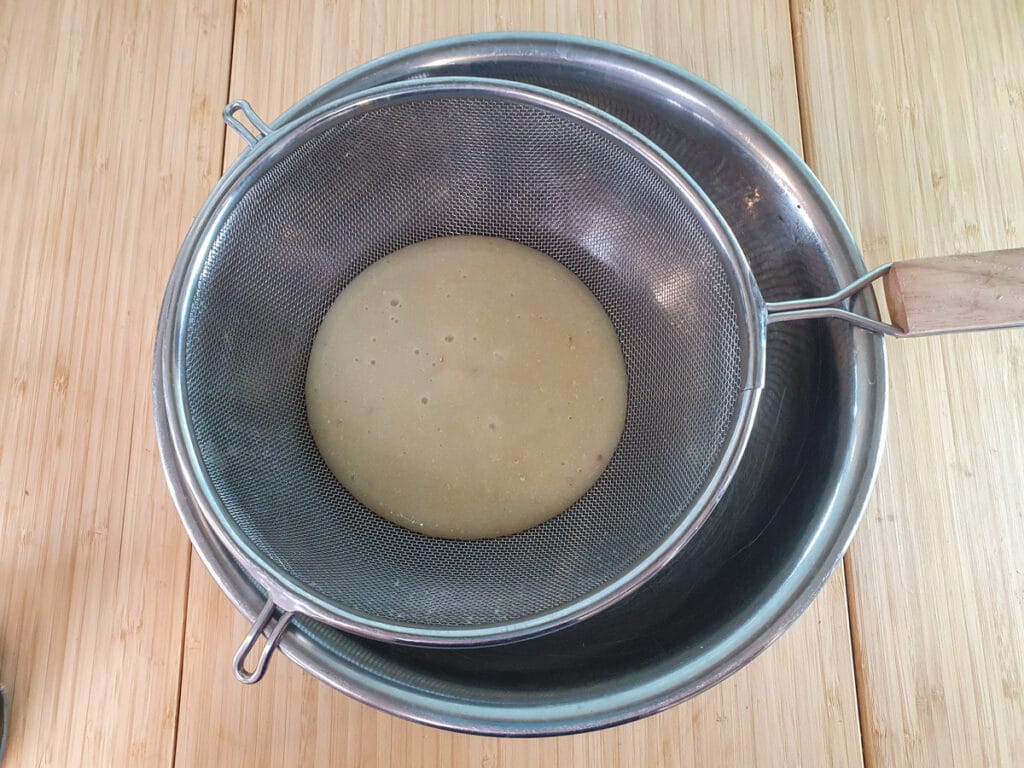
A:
177 569 861 768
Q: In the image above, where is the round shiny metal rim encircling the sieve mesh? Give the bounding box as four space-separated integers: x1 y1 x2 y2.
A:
157 77 766 647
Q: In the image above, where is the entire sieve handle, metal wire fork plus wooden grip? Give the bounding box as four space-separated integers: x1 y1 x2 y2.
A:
767 248 1024 336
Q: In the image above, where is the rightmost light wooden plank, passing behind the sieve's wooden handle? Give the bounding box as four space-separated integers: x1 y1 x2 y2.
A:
795 0 1024 766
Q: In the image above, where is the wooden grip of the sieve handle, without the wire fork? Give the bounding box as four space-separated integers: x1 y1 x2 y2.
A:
885 248 1024 336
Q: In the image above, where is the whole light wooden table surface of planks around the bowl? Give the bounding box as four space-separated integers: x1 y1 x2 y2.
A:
0 0 1024 766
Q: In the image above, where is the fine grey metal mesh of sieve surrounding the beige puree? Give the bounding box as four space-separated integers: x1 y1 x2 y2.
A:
183 87 746 628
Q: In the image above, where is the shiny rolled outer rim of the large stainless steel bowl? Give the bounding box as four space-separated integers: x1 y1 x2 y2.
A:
154 33 888 736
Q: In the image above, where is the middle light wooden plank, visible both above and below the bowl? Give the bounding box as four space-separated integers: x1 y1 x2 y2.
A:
177 0 860 766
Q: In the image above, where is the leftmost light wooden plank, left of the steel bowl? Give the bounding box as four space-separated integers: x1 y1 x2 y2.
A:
0 0 232 766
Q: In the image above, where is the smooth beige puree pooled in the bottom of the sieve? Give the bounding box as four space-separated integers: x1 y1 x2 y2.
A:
306 236 627 539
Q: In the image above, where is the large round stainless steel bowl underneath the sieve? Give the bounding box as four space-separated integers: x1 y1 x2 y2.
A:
155 34 886 735
